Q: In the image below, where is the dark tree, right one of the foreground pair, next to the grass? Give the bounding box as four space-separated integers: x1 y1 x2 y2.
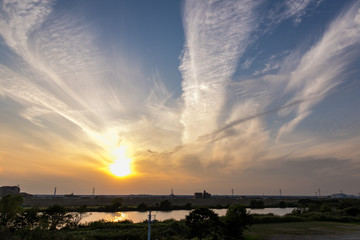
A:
223 204 252 238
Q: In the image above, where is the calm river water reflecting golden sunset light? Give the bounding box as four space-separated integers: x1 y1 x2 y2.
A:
80 208 294 223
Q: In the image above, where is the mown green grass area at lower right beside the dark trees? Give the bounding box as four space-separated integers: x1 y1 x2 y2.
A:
244 222 360 240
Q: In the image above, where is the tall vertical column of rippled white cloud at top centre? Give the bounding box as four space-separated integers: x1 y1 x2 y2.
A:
180 1 258 142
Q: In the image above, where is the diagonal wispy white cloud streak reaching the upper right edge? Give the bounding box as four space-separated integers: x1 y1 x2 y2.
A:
278 3 360 138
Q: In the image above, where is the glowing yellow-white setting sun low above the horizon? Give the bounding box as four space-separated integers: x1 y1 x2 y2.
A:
109 146 132 177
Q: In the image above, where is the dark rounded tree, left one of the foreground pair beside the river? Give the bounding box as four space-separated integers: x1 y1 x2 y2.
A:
185 208 220 239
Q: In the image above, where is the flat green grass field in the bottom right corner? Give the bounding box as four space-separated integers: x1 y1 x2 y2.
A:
244 222 360 240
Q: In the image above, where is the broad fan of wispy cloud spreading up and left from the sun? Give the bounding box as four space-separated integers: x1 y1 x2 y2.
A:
0 1 181 172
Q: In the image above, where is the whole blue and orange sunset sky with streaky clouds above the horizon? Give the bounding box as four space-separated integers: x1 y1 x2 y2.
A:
0 0 360 195
